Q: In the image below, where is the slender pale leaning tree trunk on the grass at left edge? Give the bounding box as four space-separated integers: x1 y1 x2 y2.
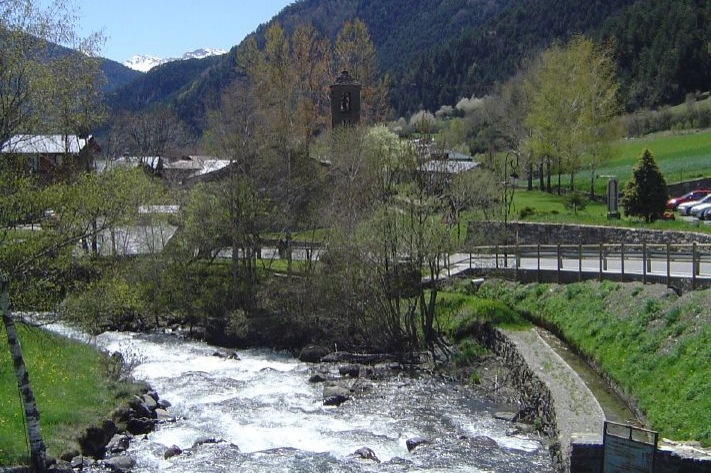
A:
0 281 47 473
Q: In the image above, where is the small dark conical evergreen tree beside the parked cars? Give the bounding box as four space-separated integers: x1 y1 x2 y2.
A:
620 149 669 223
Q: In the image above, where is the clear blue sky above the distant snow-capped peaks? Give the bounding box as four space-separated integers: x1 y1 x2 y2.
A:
47 0 294 62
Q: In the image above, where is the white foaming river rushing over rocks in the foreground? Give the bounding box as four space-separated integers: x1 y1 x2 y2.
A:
57 333 553 473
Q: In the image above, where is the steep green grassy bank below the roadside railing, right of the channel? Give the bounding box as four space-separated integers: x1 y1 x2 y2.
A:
468 281 711 446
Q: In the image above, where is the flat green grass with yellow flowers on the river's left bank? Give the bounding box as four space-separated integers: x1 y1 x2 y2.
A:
0 324 143 465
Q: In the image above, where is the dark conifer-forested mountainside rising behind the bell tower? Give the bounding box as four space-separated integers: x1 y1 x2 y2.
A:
105 0 711 133
